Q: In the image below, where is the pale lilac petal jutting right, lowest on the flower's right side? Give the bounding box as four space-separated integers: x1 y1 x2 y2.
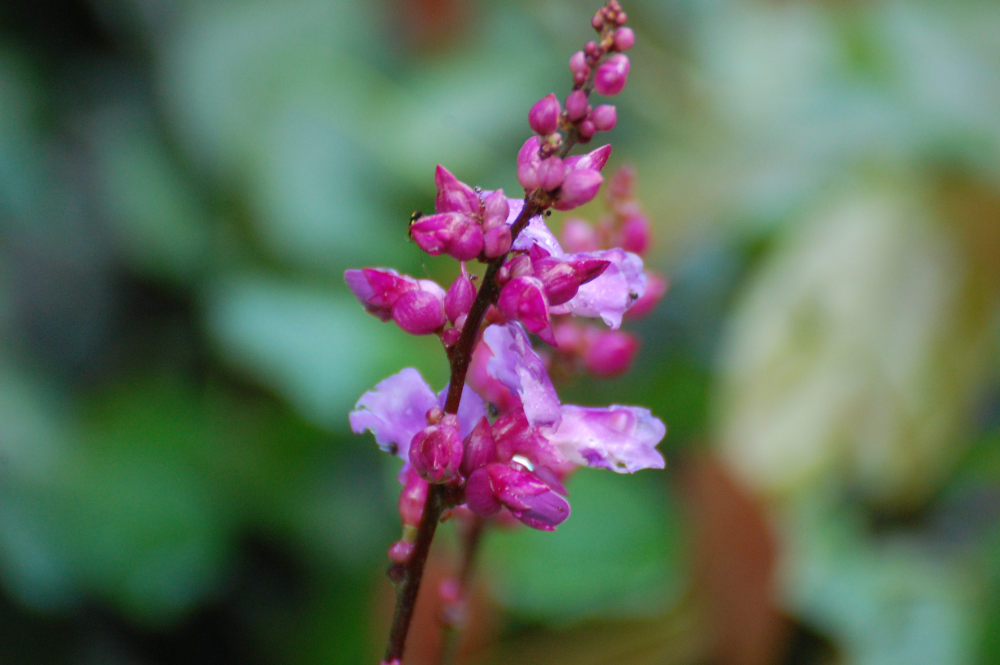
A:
545 404 667 473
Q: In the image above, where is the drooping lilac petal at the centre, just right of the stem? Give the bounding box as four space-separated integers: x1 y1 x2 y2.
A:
483 322 560 425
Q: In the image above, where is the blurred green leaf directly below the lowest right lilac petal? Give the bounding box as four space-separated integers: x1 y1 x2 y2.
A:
483 470 685 622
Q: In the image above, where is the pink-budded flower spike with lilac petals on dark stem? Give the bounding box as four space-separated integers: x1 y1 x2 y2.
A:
345 0 666 665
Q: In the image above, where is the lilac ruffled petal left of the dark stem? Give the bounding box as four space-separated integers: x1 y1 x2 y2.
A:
350 367 438 460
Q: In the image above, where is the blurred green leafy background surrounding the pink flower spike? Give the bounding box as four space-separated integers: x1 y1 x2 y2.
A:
0 0 1000 665
